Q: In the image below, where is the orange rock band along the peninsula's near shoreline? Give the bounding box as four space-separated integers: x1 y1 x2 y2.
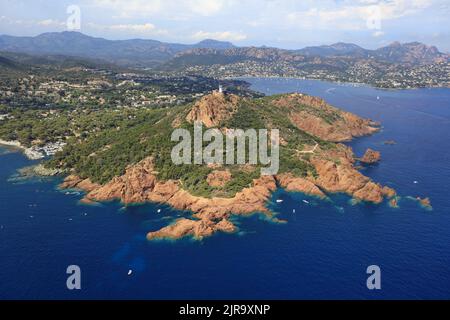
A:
60 149 396 240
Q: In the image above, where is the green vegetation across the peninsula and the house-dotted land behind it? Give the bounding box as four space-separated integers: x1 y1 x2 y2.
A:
0 55 340 197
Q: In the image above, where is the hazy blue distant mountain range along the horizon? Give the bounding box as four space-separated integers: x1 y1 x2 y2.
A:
0 31 449 67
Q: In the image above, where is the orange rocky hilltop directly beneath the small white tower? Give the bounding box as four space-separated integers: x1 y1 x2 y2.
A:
186 91 240 128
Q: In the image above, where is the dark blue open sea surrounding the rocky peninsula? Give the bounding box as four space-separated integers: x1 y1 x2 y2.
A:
0 79 450 299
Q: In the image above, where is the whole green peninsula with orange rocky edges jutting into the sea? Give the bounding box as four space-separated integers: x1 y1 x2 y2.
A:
55 92 396 240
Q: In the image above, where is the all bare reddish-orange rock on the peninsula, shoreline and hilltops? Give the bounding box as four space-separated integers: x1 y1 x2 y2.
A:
53 93 404 240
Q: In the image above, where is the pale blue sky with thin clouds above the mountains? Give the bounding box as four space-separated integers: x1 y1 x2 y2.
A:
0 0 450 52
